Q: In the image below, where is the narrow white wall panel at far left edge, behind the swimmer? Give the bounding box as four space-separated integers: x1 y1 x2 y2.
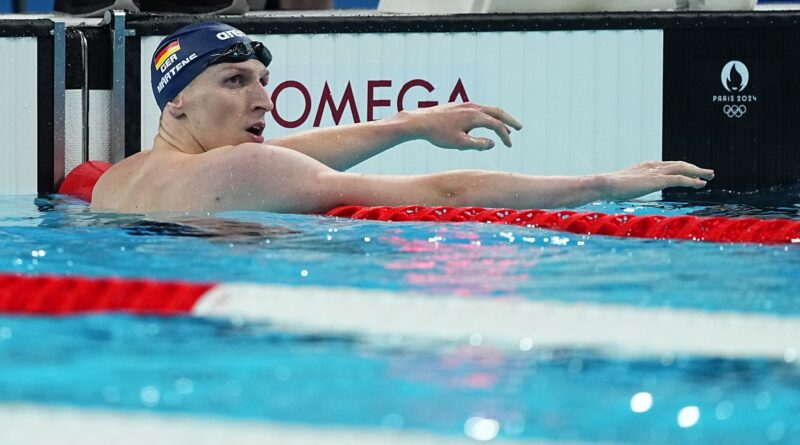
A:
0 37 38 195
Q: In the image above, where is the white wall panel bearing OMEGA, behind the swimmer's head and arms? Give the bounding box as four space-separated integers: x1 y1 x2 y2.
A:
141 30 663 174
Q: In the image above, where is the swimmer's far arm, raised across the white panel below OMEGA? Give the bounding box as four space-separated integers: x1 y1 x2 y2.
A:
267 103 522 171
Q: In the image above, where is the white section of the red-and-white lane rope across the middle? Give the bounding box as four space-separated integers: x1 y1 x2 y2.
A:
197 284 800 361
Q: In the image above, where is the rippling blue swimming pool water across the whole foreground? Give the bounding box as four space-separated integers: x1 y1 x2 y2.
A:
0 190 800 444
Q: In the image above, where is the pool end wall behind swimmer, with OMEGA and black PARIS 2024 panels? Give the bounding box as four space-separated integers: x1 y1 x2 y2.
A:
0 11 800 194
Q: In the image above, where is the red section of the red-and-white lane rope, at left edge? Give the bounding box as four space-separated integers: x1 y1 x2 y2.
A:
0 274 214 315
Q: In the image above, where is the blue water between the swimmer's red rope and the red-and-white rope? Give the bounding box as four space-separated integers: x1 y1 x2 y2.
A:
0 193 800 314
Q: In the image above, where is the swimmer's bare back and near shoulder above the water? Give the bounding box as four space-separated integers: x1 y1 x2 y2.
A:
92 143 340 213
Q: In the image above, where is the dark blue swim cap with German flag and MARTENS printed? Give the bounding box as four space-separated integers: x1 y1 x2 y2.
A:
150 22 272 110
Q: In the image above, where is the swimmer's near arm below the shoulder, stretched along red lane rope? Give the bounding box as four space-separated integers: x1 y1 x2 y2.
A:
326 161 714 209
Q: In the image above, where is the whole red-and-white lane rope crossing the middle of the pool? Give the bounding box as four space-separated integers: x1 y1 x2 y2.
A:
0 274 800 363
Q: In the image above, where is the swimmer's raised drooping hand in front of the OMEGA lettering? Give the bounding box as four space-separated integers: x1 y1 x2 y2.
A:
401 102 522 150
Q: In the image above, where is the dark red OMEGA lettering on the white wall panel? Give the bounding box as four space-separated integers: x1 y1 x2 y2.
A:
272 79 469 128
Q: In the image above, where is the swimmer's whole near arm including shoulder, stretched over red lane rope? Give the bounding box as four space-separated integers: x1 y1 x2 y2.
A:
220 144 714 213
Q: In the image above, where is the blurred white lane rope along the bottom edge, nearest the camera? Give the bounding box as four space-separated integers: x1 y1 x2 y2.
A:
0 403 576 445
